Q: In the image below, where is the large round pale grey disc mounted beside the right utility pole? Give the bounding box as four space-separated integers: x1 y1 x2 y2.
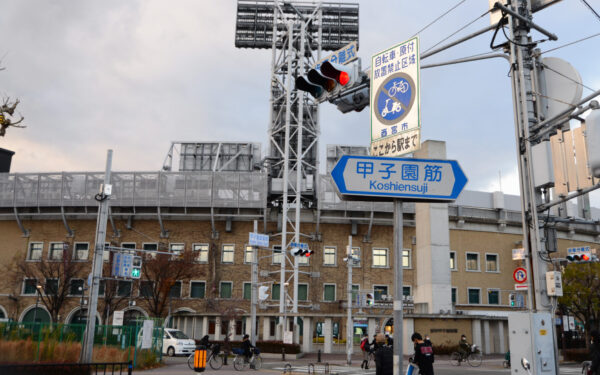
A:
539 57 583 119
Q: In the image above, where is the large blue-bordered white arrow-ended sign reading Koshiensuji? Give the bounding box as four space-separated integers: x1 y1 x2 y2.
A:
331 155 467 201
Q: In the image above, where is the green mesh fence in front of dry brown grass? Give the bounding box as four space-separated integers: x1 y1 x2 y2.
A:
0 320 163 367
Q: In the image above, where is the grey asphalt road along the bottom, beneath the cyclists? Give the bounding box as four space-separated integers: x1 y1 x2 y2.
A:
135 357 581 375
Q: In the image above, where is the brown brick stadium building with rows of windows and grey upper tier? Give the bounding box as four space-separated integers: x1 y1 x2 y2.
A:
0 142 600 353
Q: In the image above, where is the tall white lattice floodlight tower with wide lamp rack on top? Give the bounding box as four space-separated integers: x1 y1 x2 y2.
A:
235 0 358 337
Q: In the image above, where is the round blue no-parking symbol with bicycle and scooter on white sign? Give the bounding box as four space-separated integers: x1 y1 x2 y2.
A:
375 73 415 125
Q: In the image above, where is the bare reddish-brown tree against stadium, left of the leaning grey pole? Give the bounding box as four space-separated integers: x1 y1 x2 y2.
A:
11 242 86 322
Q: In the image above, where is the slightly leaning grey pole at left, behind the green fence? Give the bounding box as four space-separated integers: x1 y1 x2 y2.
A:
79 150 112 363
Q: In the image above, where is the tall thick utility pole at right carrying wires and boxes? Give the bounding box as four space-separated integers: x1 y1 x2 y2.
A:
504 0 559 374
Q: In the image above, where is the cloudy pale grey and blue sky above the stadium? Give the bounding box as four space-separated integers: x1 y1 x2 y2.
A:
0 0 600 206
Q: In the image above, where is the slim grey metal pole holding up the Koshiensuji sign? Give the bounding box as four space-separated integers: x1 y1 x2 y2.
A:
394 199 404 375
